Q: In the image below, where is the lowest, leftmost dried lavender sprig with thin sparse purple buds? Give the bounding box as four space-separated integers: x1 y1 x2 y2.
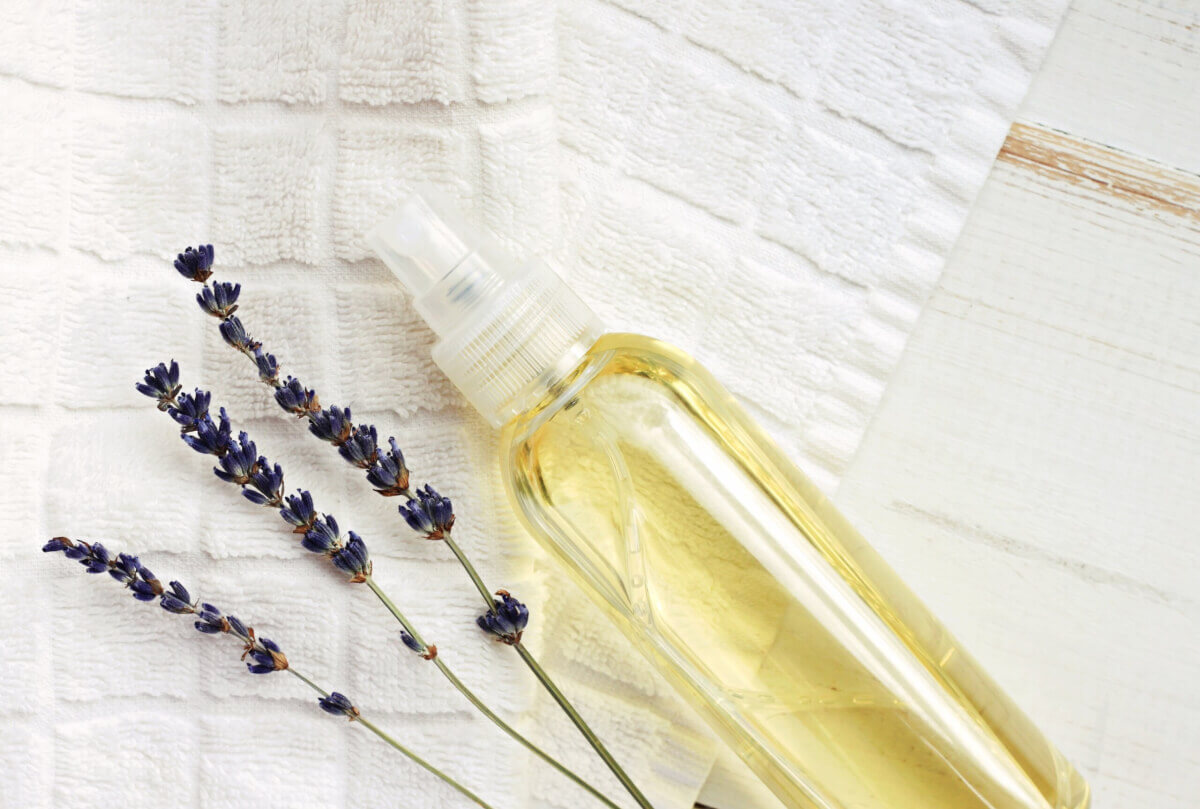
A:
42 537 492 809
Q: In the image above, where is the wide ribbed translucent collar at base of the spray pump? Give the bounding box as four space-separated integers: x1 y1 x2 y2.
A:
427 262 604 427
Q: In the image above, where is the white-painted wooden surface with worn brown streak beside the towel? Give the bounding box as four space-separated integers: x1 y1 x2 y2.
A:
838 0 1200 809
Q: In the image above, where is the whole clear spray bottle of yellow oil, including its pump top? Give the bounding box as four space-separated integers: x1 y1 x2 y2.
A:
370 197 1088 809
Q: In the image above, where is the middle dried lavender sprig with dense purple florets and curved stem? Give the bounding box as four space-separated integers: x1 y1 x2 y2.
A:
137 360 618 809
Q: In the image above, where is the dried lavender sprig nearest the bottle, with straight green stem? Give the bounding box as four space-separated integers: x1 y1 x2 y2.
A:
174 245 653 809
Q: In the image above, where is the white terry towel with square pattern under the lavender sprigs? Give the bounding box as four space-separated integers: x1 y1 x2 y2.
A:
0 0 1064 809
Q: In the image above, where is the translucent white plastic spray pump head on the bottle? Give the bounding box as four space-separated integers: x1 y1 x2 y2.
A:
367 194 602 426
